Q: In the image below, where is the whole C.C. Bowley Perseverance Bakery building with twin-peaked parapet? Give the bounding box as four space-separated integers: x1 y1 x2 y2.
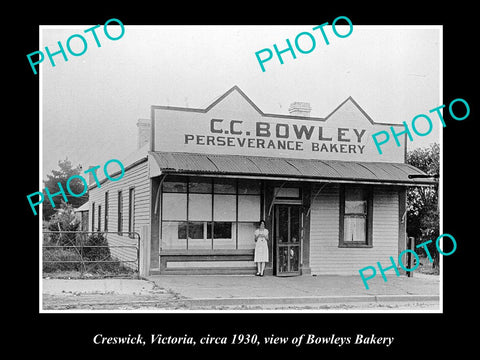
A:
88 86 433 276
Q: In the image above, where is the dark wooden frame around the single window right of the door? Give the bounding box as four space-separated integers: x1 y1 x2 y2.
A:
338 184 373 248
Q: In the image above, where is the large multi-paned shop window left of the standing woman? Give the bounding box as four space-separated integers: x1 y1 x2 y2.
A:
161 175 262 250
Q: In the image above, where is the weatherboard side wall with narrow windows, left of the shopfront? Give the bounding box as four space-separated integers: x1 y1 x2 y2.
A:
89 159 150 269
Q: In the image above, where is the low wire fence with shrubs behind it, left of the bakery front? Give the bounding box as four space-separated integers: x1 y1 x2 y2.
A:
42 231 140 277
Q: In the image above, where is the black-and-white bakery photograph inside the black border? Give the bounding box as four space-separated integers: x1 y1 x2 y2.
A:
37 23 442 312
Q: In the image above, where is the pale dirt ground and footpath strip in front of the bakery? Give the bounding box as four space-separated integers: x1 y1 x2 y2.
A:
41 274 439 312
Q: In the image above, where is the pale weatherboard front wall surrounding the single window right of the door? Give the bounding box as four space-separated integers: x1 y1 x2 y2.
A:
310 184 400 275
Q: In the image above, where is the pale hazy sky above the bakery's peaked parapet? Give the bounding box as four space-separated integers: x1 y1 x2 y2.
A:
37 23 443 178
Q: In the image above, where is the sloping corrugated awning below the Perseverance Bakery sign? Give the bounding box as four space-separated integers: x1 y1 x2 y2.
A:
149 152 436 186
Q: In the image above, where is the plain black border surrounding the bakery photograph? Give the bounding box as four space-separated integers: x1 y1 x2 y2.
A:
11 1 479 358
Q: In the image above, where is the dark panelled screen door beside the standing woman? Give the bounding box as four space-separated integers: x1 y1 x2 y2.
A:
273 204 302 276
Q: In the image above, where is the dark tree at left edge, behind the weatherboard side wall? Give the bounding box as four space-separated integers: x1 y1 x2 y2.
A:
42 158 88 220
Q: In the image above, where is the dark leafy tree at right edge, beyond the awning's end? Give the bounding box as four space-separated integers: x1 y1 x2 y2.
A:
407 143 440 268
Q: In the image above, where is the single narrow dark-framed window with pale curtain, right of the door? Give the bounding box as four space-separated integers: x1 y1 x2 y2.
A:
339 185 373 247
